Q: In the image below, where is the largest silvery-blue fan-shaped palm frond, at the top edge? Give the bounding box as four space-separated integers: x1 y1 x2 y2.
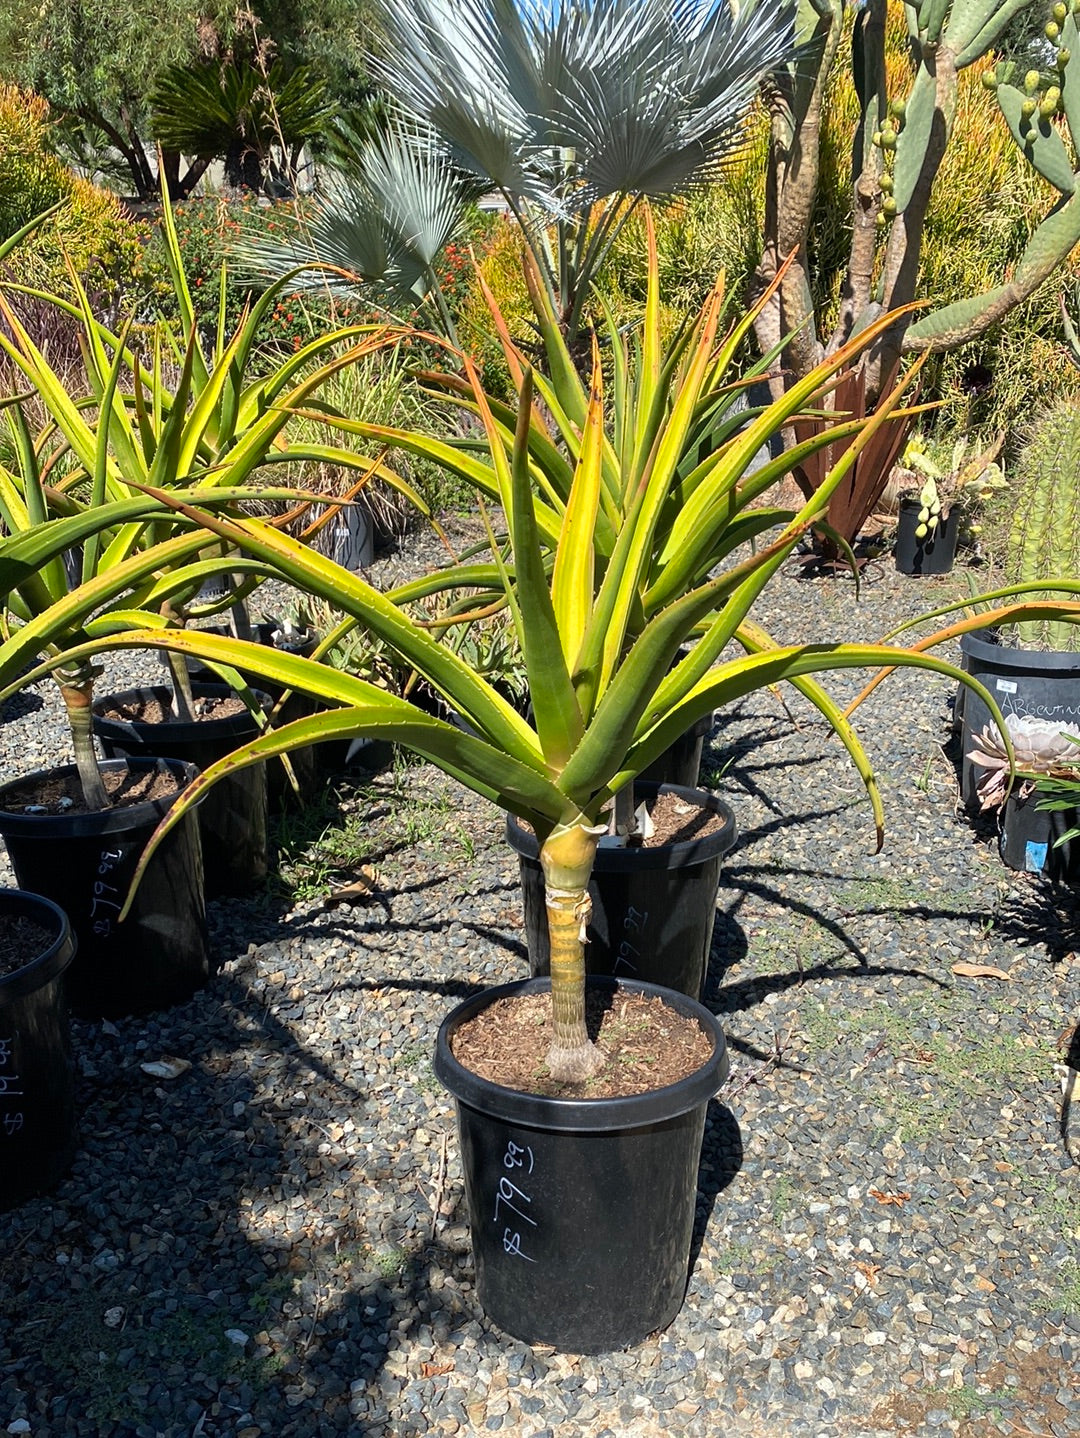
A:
368 0 795 214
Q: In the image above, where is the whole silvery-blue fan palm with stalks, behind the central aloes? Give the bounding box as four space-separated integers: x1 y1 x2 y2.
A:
246 0 795 344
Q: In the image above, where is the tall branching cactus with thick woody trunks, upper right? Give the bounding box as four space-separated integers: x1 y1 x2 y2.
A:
758 0 1080 397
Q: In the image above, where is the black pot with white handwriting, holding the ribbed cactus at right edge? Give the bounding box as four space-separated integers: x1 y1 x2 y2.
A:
961 630 1080 808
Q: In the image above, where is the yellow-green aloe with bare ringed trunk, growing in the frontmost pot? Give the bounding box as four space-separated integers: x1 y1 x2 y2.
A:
21 274 1080 1081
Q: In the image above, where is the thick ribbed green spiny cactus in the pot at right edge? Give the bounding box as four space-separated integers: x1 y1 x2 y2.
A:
1007 400 1080 650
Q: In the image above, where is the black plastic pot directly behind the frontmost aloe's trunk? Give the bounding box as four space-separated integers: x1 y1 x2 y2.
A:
506 784 738 998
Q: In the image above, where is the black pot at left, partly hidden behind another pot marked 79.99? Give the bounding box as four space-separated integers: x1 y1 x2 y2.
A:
93 684 270 899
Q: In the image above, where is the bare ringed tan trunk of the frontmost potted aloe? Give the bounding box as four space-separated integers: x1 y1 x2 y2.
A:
539 824 607 1083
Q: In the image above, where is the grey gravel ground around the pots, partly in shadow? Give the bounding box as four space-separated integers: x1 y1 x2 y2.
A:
0 540 1080 1438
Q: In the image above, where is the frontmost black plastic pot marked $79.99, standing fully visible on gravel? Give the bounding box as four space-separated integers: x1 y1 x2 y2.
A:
434 979 728 1353
